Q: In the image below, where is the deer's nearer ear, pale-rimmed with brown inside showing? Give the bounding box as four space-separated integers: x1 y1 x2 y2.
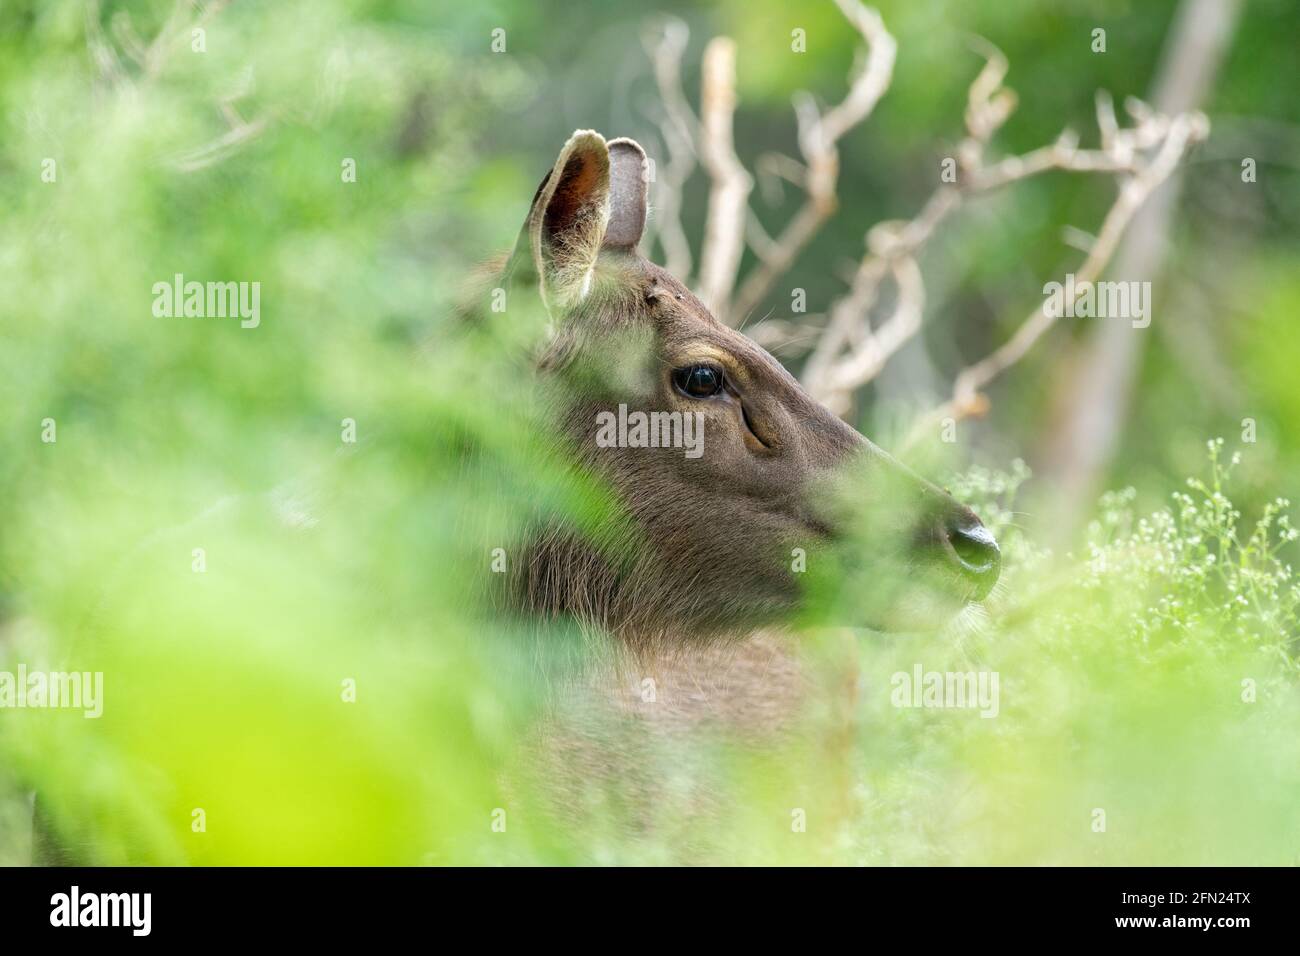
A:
528 130 610 304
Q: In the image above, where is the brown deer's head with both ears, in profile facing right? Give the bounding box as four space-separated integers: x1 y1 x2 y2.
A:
507 130 1000 640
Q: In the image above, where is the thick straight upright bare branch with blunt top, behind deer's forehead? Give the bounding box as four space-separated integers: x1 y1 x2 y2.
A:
698 36 754 315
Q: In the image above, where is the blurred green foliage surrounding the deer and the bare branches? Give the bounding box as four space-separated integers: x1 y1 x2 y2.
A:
0 0 1300 864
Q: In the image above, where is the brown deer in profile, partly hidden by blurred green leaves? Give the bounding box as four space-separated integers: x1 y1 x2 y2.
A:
483 130 1001 848
